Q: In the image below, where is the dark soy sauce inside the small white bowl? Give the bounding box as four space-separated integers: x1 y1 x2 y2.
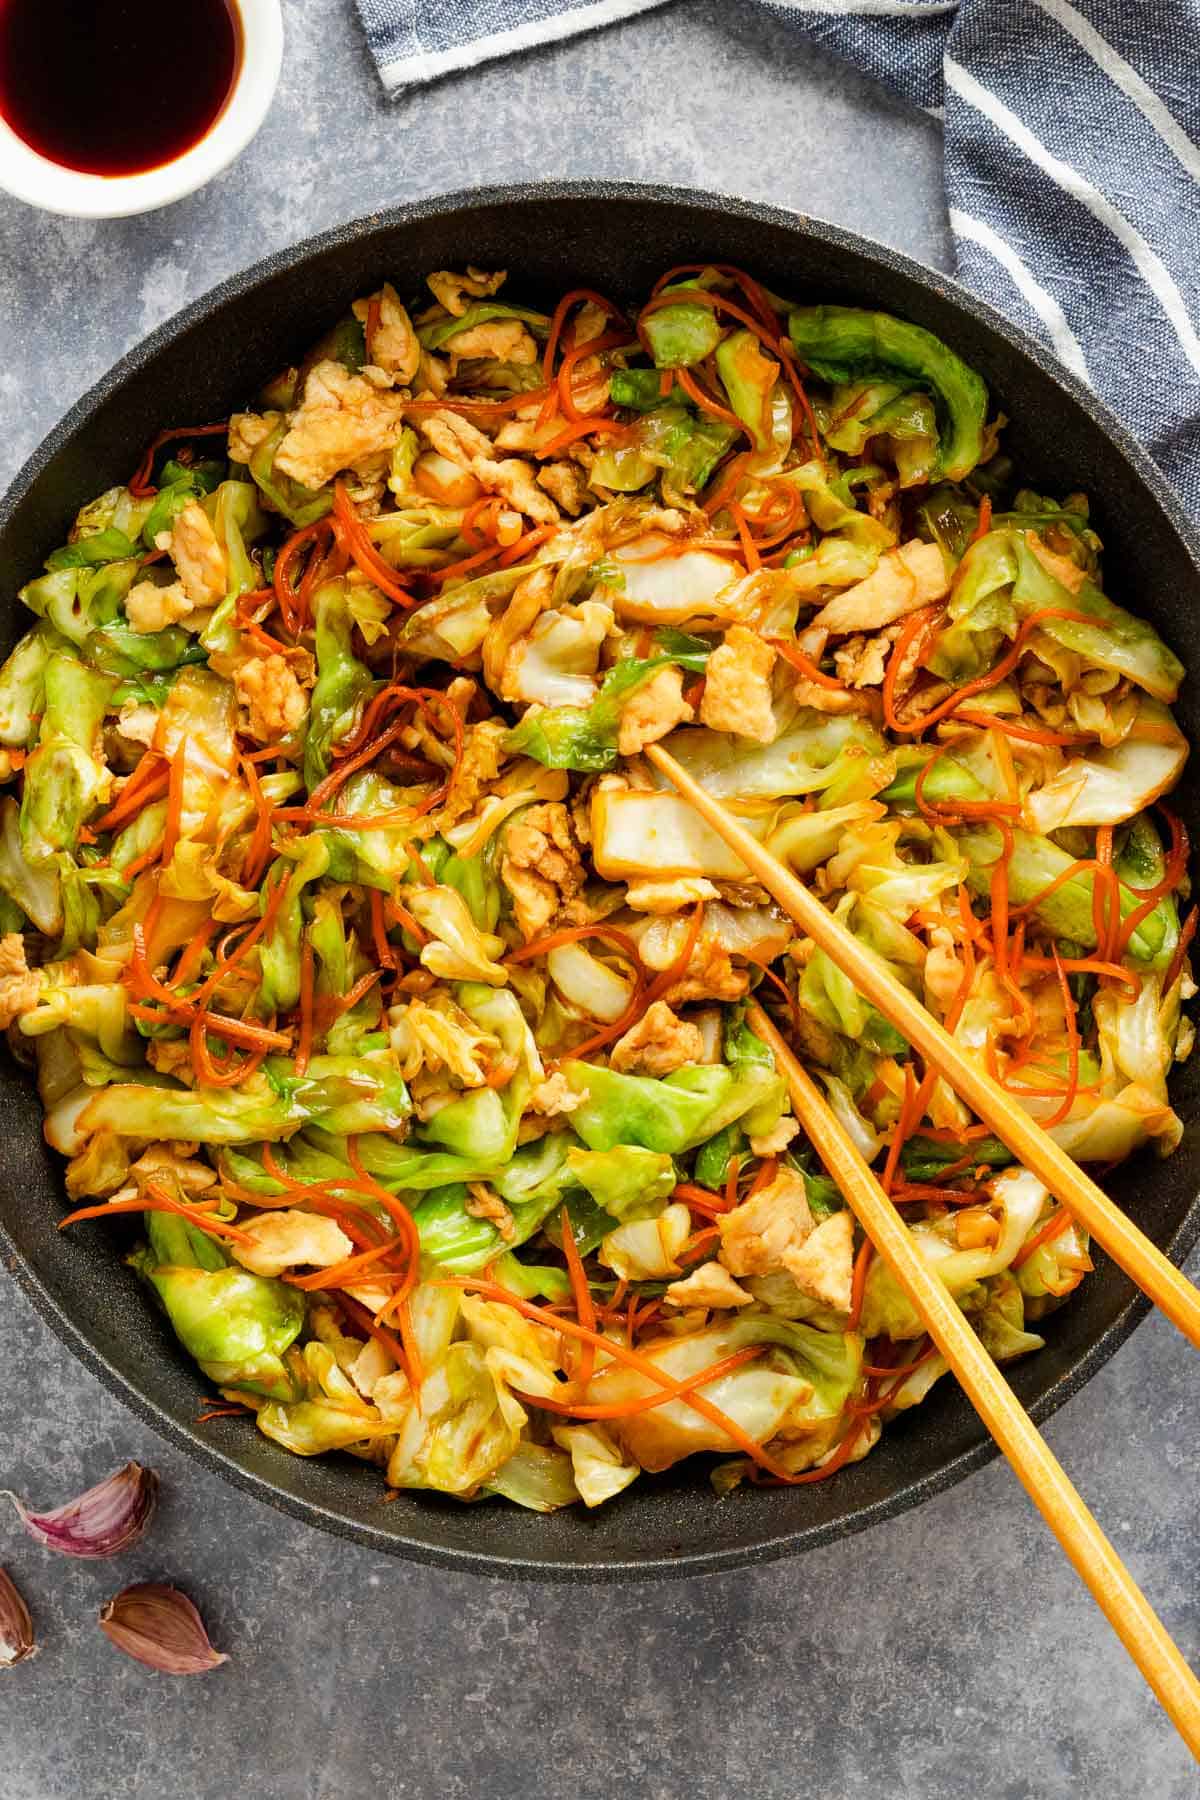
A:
0 0 241 175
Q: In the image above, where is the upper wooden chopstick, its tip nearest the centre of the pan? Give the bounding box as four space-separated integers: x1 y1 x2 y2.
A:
642 743 1200 1350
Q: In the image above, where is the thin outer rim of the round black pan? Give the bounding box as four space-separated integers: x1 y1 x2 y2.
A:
0 178 1200 1582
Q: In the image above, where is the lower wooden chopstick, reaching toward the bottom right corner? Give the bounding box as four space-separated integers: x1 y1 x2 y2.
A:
747 1003 1200 1759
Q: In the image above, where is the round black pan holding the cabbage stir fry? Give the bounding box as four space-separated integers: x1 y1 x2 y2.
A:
0 184 1200 1579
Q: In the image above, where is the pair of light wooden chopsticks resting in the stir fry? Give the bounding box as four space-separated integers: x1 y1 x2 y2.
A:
642 743 1200 1760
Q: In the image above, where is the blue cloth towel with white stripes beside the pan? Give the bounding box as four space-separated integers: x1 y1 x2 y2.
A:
358 0 1200 517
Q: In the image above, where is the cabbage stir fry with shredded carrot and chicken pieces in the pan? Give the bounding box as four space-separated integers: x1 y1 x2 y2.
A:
0 266 1195 1512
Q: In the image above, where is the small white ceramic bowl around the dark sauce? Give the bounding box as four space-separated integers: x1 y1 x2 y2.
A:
0 0 282 220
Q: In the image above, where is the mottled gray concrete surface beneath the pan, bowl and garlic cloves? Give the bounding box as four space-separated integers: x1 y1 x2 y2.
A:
0 0 1200 1800
